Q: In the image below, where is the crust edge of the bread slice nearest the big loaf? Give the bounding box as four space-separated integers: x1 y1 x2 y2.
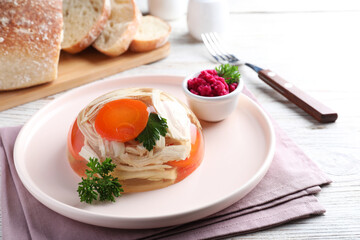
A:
62 0 111 54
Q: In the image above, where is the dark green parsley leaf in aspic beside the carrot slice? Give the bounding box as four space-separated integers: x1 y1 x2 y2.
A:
136 113 168 151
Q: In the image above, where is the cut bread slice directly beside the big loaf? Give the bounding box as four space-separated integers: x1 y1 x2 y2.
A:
61 0 111 53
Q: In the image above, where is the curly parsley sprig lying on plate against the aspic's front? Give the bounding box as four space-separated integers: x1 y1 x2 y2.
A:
77 158 124 204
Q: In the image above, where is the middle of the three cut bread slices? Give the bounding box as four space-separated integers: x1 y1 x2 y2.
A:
93 0 141 57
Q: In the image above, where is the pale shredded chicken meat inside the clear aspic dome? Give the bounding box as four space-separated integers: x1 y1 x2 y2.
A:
77 88 199 181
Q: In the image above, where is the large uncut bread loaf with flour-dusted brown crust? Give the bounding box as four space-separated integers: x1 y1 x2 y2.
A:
0 0 63 90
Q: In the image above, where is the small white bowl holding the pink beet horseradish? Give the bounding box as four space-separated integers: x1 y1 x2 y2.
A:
182 72 244 122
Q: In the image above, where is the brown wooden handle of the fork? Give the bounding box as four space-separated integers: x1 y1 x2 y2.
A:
258 69 338 123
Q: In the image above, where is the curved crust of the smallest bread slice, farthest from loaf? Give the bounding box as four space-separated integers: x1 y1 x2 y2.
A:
130 16 171 52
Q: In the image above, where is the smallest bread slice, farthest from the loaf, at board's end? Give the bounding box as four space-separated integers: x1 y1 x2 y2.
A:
130 15 171 52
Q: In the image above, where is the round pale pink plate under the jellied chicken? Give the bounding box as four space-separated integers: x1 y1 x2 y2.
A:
14 76 275 229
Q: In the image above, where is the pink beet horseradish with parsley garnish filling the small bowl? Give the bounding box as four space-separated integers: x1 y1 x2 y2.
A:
187 64 240 97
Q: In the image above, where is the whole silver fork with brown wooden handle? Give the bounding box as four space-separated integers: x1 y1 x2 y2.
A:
201 32 338 123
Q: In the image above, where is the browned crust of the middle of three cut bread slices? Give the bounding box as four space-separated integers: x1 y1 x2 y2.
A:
92 0 142 57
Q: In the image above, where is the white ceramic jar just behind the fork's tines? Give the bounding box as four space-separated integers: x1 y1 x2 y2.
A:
187 0 229 41
